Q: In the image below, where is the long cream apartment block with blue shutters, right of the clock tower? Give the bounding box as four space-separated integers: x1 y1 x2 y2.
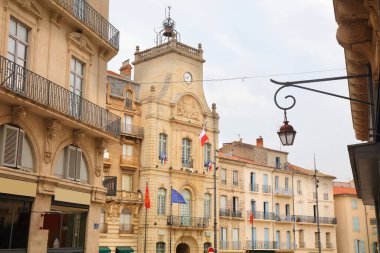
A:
218 137 337 252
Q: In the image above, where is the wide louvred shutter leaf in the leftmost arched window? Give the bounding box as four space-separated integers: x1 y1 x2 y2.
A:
1 125 19 167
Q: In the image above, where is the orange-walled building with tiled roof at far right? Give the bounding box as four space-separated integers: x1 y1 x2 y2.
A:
334 181 378 253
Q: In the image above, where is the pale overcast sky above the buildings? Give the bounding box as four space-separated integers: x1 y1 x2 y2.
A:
108 0 358 181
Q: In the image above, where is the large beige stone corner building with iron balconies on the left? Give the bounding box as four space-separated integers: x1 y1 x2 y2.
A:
0 0 120 253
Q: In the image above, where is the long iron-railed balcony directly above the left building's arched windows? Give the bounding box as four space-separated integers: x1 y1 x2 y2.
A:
0 56 120 137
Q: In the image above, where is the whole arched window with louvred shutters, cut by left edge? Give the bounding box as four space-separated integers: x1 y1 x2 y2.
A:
0 124 34 171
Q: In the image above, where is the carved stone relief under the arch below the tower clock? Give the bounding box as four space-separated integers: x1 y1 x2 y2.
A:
177 95 202 121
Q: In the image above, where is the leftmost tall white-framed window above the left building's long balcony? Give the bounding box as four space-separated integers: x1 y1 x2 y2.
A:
8 19 29 68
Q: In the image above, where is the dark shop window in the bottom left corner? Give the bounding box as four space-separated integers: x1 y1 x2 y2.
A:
0 198 32 249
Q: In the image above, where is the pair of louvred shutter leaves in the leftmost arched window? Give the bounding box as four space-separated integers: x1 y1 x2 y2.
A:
0 125 25 168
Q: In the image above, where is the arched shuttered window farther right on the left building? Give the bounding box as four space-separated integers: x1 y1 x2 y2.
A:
55 145 88 183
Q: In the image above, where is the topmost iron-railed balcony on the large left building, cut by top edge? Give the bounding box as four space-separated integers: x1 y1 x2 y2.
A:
54 0 119 50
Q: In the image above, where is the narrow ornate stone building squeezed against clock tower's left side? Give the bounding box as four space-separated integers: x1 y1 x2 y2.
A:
99 60 144 253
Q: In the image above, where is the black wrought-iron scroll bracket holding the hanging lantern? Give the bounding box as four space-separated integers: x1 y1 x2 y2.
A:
270 74 373 111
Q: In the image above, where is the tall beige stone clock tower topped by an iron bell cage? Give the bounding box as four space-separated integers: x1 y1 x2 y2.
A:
133 9 219 253
